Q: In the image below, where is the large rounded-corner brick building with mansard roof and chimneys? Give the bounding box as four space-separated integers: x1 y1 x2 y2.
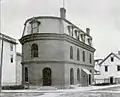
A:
20 8 95 87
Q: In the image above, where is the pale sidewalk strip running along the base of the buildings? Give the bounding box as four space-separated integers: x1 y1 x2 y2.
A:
2 84 120 93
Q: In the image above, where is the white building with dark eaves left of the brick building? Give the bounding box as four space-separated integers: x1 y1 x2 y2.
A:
0 33 21 86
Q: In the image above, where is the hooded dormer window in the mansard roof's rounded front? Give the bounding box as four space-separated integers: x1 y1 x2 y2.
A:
30 18 40 33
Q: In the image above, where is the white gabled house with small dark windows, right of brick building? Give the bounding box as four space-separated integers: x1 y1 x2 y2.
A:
94 51 120 84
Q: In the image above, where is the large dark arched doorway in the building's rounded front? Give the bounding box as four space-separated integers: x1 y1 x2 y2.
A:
42 67 52 86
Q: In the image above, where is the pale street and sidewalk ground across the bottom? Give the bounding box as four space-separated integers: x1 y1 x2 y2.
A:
2 85 120 97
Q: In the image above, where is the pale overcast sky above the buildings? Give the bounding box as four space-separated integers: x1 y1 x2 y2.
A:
0 0 120 59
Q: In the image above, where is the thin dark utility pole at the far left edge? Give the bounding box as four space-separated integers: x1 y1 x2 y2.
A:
0 33 3 93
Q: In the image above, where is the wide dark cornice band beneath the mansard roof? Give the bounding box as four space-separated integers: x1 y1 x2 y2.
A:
19 33 95 52
